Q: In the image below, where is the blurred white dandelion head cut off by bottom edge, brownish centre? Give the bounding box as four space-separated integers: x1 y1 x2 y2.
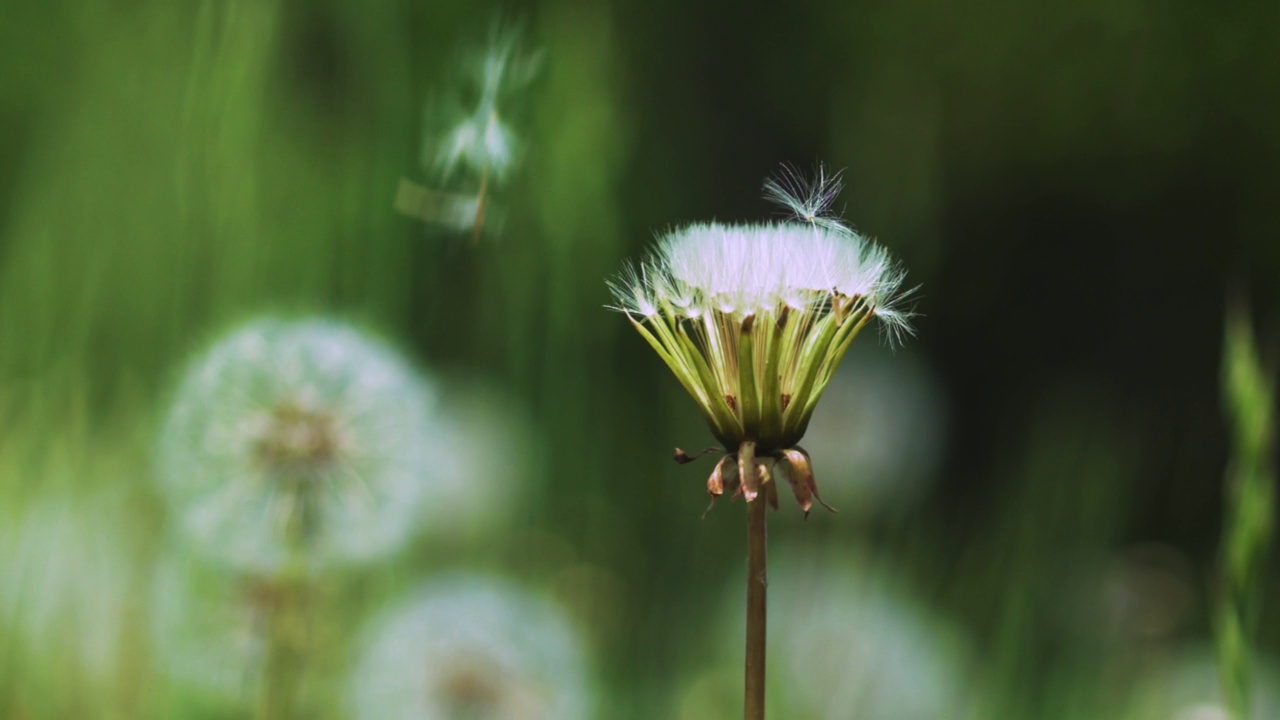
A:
348 574 593 720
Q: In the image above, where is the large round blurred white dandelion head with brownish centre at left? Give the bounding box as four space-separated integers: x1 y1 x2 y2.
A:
157 318 436 574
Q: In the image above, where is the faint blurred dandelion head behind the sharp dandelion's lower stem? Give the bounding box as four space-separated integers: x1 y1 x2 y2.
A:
677 544 973 720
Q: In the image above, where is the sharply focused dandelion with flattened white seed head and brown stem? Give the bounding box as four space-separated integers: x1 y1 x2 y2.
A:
611 163 911 717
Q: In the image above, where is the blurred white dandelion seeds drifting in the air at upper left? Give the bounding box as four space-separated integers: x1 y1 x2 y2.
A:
396 20 544 242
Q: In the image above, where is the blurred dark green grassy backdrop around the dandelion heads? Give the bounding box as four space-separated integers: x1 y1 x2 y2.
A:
0 0 1280 717
